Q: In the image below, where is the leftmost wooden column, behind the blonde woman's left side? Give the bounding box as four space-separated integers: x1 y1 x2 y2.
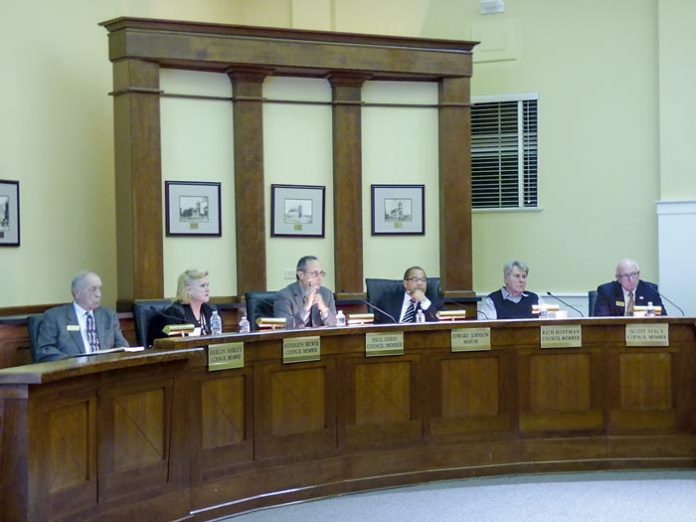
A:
113 59 164 311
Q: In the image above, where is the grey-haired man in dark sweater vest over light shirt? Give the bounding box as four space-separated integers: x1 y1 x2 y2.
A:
481 259 540 319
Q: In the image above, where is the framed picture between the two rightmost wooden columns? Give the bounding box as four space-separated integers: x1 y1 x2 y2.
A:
372 181 425 236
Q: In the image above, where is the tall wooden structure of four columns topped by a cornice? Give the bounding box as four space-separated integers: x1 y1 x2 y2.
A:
101 18 476 306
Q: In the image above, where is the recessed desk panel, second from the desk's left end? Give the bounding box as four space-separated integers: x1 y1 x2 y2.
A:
114 389 165 472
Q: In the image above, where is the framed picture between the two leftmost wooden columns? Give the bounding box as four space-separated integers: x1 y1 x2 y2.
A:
164 181 222 236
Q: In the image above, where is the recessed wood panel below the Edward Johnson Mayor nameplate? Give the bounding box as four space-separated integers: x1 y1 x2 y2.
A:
441 357 500 418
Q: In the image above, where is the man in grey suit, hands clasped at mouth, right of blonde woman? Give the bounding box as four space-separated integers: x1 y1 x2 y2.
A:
273 256 336 328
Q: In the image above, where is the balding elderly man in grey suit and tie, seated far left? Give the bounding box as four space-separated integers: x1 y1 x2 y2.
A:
37 272 128 362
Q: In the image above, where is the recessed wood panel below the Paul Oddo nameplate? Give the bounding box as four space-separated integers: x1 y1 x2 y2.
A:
355 362 411 426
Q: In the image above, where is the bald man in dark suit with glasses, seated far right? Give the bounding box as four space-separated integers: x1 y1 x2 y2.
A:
593 259 667 316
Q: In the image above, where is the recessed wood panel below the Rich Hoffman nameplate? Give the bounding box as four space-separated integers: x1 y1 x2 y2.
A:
530 354 591 413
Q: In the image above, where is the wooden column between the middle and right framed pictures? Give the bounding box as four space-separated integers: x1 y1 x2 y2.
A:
328 73 369 299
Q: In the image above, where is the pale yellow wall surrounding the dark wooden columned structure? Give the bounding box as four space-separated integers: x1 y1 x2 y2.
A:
0 0 696 307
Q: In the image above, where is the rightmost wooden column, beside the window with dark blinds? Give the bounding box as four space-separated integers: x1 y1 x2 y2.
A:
438 77 474 298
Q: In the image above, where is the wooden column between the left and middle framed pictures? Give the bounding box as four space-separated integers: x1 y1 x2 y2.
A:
227 68 272 296
